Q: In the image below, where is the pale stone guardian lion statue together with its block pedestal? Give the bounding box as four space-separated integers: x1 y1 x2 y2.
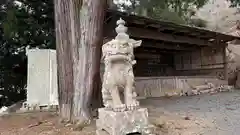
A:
96 19 153 135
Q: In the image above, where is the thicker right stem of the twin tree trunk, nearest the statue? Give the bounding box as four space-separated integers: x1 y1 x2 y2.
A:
73 0 107 123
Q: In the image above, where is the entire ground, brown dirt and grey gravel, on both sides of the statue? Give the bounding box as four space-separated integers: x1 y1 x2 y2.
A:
0 91 240 135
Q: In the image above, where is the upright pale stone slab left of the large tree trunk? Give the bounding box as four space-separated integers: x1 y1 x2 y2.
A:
26 49 58 108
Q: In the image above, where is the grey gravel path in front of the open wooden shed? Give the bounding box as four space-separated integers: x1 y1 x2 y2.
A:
142 90 240 135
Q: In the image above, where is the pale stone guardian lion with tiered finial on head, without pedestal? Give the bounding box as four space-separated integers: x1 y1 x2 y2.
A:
102 19 142 112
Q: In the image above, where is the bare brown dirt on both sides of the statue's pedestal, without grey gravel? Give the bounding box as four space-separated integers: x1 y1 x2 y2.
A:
0 107 212 135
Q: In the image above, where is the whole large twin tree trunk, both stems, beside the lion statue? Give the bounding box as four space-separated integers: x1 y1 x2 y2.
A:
55 0 106 123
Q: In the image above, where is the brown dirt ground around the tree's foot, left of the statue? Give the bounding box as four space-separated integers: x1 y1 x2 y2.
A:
0 112 95 135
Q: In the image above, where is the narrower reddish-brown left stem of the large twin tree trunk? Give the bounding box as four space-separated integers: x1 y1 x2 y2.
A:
54 0 74 120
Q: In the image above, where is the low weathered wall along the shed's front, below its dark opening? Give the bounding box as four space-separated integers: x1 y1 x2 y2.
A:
136 76 227 98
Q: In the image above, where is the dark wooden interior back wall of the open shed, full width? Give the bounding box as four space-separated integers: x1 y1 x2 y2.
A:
101 39 225 77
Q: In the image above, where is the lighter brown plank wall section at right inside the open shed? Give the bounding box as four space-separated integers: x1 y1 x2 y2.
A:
174 47 225 76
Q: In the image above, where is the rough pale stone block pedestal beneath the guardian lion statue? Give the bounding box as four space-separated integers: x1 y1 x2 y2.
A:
96 108 154 135
